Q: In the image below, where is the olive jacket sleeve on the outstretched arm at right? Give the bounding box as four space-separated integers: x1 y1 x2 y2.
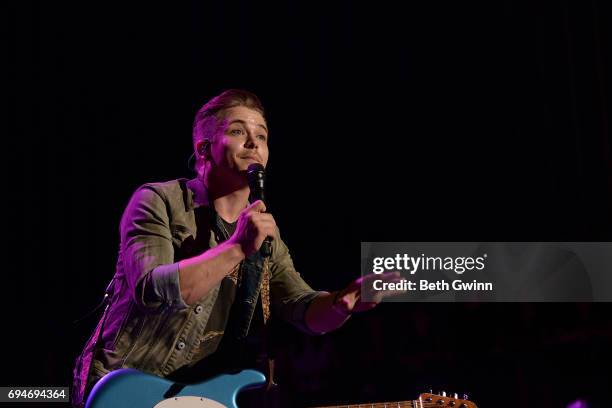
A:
270 235 324 334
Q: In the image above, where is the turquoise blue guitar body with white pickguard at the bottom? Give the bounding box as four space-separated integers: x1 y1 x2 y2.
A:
85 368 266 408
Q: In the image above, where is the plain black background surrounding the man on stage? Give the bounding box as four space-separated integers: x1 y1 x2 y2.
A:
1 0 612 407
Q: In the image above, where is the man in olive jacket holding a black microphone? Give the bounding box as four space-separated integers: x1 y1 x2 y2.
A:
72 90 399 406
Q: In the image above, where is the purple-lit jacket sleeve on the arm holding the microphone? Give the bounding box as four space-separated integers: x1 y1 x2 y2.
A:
120 185 187 312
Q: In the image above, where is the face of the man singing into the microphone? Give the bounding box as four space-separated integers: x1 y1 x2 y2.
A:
210 106 268 172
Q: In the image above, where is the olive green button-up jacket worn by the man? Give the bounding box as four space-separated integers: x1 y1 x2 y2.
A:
72 179 319 406
